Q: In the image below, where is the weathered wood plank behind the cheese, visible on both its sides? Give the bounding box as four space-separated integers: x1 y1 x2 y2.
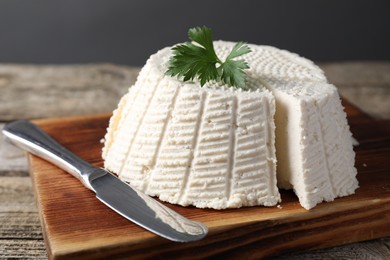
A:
0 62 390 121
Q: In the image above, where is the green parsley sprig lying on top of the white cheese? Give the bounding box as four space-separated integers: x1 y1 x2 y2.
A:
166 26 251 88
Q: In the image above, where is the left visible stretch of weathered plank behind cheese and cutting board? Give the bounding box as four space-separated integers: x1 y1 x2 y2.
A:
0 64 139 121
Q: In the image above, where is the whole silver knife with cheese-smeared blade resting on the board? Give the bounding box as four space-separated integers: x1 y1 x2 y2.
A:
3 120 208 242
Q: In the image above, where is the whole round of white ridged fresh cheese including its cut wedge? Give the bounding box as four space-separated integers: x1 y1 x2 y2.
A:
103 41 358 209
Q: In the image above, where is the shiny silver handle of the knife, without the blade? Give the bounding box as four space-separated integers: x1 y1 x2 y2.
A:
3 120 94 191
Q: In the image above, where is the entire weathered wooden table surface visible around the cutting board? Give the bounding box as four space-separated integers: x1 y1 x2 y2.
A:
0 62 390 259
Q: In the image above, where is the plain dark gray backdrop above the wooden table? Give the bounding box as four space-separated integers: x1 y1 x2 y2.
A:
0 0 390 66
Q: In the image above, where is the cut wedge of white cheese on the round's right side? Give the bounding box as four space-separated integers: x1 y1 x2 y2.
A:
267 80 358 209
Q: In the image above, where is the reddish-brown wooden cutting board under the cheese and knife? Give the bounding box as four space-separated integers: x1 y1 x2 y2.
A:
29 101 390 259
